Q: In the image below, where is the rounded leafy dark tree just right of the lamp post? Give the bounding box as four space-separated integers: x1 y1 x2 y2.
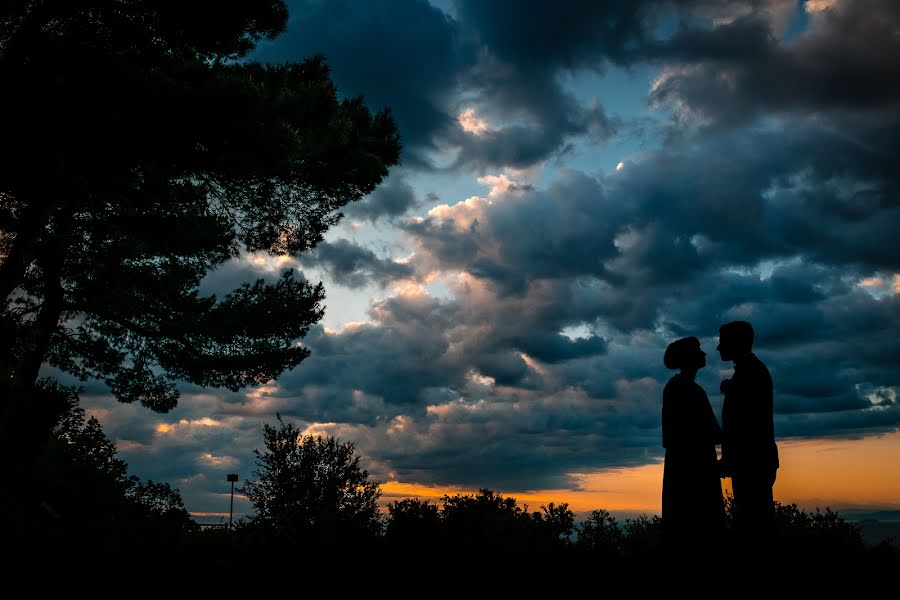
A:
240 415 382 545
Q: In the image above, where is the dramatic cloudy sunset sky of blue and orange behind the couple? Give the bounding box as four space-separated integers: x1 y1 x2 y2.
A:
75 0 900 513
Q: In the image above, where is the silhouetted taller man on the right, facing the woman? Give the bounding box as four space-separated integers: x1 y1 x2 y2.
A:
716 321 778 539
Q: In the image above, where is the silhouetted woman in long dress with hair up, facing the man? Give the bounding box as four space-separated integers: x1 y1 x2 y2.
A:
662 337 725 547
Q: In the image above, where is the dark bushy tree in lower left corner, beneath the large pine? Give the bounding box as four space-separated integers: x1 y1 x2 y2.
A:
7 379 196 551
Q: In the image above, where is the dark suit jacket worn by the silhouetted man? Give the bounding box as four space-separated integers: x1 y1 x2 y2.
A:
722 352 778 476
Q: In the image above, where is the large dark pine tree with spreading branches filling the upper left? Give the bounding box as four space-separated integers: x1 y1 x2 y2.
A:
0 0 399 455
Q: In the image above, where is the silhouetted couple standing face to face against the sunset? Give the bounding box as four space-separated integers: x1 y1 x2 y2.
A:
662 321 778 550
